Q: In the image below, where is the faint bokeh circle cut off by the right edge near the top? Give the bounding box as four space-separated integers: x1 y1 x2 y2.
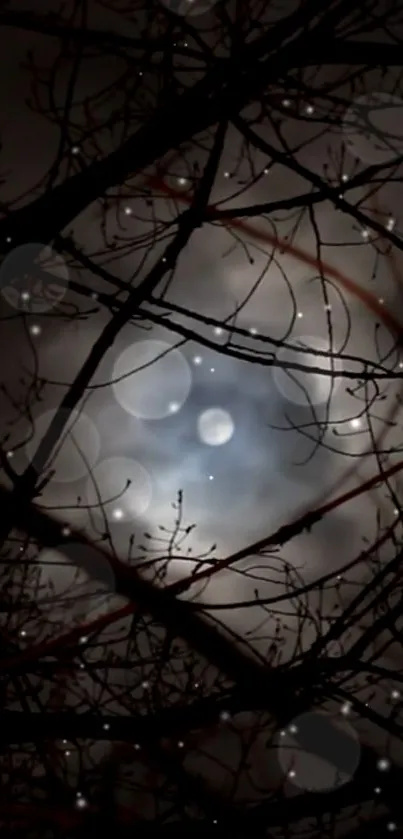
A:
343 93 403 165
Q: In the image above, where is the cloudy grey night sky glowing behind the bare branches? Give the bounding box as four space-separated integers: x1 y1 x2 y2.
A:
0 0 403 836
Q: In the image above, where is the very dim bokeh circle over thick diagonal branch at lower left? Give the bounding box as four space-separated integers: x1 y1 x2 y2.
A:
38 542 116 625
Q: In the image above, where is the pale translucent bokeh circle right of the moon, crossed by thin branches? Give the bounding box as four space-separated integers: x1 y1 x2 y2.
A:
273 336 343 407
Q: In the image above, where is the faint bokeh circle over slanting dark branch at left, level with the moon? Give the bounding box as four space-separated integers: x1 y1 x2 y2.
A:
25 410 101 484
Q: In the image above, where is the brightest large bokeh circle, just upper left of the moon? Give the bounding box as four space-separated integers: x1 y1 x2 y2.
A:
113 340 192 420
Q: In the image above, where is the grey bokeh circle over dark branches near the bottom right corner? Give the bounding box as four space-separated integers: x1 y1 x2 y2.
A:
278 711 361 792
